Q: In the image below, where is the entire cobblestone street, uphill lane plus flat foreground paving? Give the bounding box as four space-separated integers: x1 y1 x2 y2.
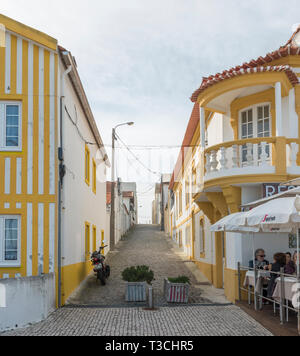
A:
0 225 271 336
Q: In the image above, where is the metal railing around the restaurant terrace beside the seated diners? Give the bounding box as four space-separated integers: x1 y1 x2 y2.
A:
237 263 300 335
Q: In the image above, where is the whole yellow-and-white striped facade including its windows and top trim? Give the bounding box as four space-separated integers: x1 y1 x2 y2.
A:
0 15 58 279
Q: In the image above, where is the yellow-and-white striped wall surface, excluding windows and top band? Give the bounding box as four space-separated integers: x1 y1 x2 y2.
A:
0 31 58 279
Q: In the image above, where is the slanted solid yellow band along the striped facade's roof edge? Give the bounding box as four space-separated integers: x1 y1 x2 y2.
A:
0 14 57 51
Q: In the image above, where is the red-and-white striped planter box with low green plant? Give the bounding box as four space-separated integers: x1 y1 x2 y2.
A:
164 276 191 304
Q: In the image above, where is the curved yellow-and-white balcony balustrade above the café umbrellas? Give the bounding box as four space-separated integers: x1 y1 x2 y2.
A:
204 137 300 183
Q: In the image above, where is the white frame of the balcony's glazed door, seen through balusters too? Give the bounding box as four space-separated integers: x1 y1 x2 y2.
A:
239 102 272 165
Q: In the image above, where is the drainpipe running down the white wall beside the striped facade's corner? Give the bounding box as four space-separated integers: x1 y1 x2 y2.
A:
57 59 72 308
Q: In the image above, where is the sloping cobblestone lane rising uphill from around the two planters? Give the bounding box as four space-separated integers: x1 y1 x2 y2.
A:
68 225 209 306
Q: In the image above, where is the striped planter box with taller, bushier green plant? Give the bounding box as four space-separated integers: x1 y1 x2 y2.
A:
122 266 154 302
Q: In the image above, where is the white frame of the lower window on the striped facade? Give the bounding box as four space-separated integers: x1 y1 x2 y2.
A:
0 215 21 268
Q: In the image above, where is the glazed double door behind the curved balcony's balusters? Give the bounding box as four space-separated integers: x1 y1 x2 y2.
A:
240 104 271 163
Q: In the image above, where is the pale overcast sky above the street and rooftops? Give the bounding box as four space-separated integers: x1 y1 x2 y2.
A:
0 0 300 222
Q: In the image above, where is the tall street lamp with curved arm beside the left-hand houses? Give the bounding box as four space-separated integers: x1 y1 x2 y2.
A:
110 122 134 251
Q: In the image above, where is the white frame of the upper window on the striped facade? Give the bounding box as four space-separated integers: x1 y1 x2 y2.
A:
0 100 22 152
